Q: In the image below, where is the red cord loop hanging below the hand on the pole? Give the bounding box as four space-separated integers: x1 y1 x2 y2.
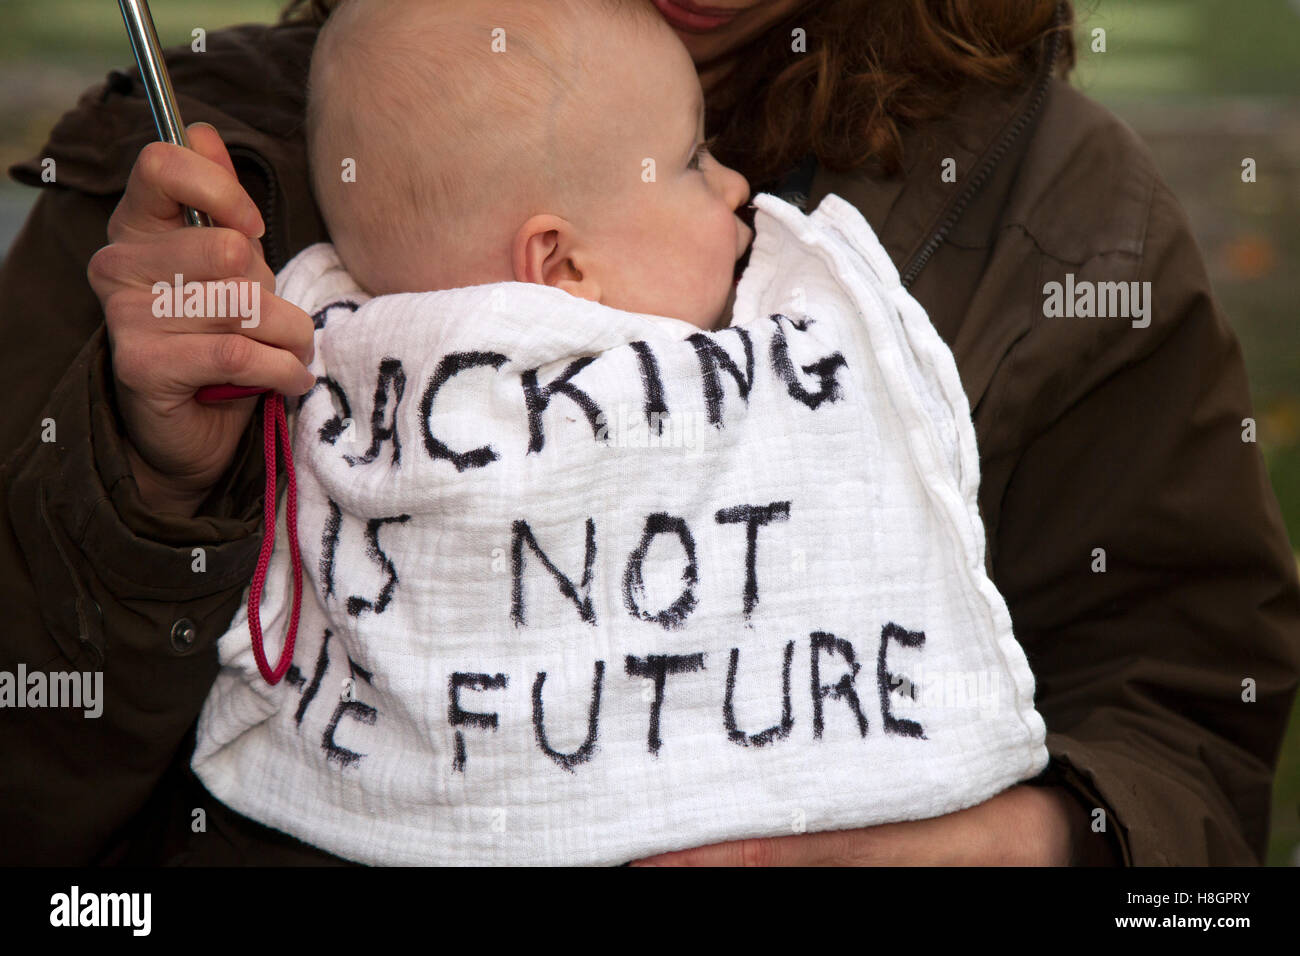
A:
248 394 303 685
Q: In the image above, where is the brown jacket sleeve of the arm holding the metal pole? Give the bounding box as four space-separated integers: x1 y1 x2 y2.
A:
0 153 301 864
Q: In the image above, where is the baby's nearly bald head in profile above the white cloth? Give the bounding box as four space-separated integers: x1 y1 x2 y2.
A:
307 0 751 328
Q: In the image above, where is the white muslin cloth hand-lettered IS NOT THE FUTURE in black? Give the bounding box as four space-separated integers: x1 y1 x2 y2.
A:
194 195 1048 864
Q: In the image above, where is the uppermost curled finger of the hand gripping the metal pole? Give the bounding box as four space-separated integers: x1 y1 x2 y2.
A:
108 140 265 242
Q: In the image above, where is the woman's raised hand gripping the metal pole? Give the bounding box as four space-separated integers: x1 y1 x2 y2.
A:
87 124 313 515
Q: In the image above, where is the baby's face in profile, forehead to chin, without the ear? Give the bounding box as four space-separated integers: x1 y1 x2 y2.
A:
548 9 753 329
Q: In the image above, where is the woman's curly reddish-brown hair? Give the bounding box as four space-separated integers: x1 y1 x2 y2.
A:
281 0 1075 185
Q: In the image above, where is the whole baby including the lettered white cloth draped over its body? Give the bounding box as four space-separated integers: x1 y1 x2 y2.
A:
192 0 1047 864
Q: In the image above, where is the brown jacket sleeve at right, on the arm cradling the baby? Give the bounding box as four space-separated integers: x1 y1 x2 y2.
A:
995 174 1300 865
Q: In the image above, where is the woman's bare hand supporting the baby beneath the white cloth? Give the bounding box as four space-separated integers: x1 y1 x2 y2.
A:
632 784 1087 866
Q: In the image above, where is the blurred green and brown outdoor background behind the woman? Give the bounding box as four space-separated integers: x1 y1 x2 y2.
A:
0 0 1300 865
